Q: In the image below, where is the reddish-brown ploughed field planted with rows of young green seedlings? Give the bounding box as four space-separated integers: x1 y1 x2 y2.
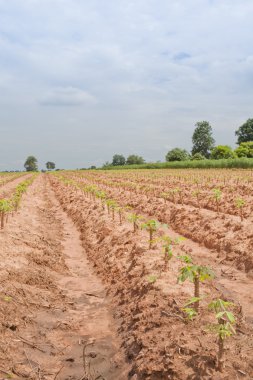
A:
0 169 253 380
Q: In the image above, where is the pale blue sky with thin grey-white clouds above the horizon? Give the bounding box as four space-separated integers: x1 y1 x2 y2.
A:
0 0 253 170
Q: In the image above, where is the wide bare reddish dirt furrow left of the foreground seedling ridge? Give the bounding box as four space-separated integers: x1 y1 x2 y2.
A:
0 176 129 380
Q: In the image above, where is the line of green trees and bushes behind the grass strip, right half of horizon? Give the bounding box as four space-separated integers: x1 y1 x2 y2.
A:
103 119 253 167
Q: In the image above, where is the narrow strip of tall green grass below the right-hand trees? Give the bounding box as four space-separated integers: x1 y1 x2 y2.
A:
99 158 253 170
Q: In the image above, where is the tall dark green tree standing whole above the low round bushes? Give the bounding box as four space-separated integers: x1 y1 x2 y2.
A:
192 121 215 158
